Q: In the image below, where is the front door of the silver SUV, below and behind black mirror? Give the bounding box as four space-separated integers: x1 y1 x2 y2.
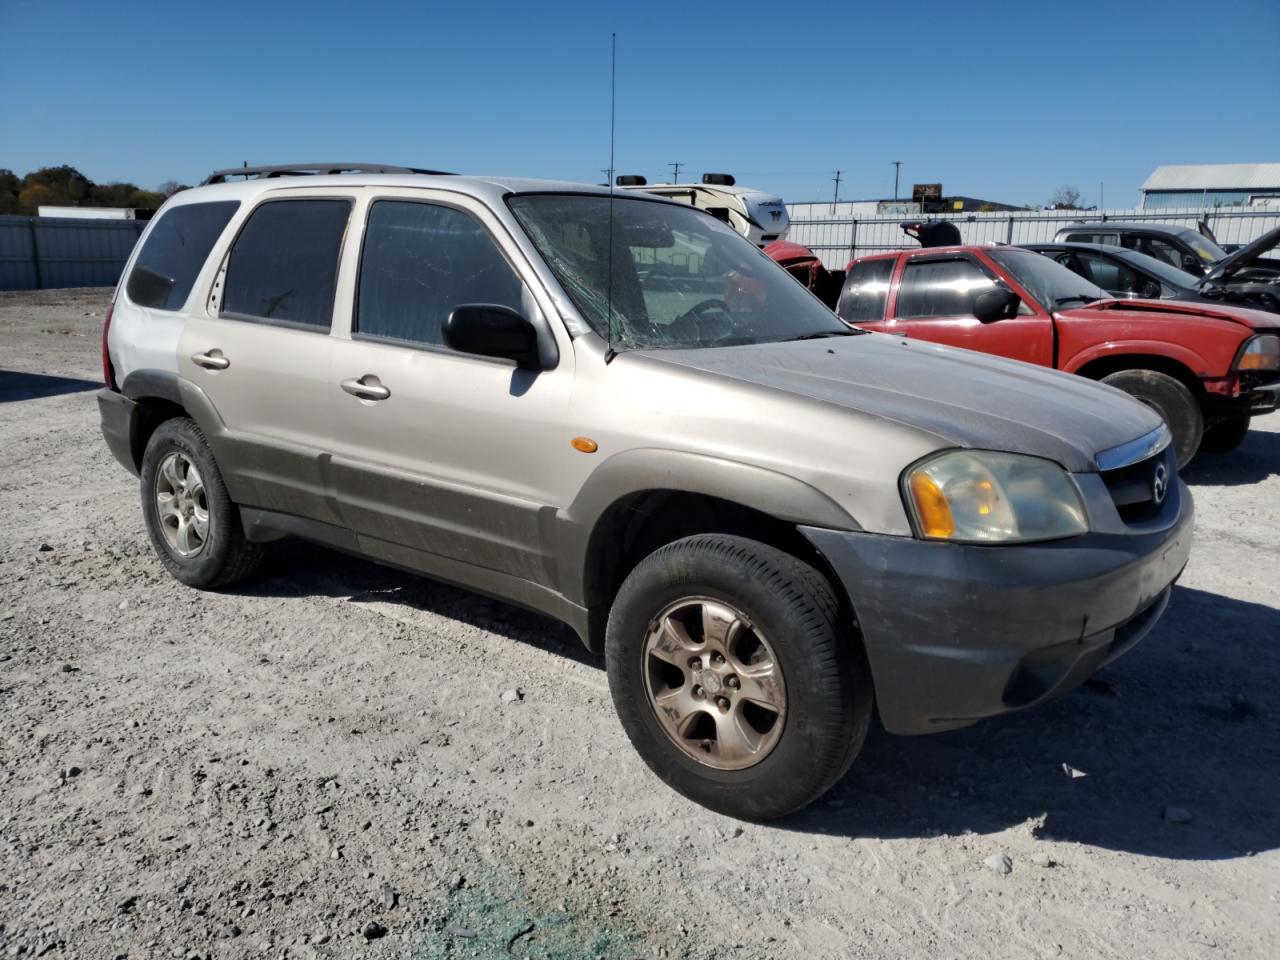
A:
324 191 573 591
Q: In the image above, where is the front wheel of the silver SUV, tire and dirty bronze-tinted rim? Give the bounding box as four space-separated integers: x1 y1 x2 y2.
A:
605 534 873 820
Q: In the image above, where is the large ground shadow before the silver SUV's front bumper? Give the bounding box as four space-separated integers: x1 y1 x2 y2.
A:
778 588 1280 860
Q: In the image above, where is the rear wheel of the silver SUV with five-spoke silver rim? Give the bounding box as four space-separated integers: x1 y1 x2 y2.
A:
141 419 262 590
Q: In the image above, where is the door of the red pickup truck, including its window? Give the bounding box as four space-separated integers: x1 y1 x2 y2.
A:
874 251 1053 366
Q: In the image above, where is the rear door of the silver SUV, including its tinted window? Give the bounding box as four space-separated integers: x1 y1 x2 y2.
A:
178 191 355 525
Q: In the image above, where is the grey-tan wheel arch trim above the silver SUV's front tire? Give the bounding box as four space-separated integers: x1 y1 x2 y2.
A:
556 448 861 605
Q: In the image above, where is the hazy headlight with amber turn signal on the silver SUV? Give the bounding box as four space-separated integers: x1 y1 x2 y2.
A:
902 451 1089 543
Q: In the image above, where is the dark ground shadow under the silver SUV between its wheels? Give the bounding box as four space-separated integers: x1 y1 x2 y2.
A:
232 539 593 669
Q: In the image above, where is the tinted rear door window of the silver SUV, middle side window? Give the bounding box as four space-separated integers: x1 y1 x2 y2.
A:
221 200 351 330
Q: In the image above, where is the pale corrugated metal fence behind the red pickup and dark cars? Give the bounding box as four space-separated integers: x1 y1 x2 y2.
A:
787 204 1280 270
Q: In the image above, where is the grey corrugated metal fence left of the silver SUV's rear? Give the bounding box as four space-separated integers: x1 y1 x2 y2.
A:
0 216 147 291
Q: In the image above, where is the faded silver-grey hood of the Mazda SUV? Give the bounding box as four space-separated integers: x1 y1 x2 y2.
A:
645 334 1161 472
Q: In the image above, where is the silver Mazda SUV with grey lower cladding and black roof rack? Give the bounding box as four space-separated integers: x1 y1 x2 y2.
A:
99 164 1192 819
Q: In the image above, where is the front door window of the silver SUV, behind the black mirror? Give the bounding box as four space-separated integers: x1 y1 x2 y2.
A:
353 200 524 344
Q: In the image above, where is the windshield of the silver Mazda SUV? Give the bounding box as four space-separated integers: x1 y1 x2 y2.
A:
508 193 854 349
